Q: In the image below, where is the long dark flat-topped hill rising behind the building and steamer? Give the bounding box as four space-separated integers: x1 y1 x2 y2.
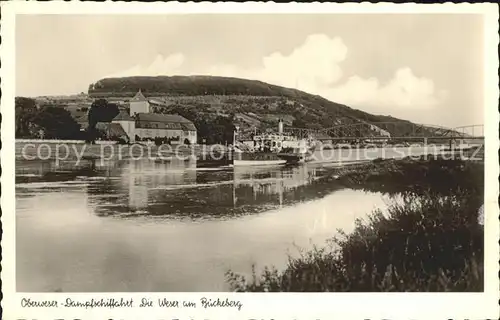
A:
88 76 430 136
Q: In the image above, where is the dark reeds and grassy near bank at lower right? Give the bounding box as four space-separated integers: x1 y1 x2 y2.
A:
226 156 484 292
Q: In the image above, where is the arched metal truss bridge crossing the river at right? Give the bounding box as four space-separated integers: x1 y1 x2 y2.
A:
285 121 484 143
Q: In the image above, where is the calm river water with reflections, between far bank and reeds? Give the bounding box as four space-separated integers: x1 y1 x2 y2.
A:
16 146 438 292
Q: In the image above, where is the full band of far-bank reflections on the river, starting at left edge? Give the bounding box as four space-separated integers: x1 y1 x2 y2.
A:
16 159 340 219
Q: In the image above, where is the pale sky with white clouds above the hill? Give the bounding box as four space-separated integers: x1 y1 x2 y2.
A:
16 14 484 127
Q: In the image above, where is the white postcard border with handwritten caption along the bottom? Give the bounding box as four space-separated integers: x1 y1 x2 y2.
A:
0 2 499 320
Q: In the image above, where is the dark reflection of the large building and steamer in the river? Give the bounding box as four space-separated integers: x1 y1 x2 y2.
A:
83 161 318 219
